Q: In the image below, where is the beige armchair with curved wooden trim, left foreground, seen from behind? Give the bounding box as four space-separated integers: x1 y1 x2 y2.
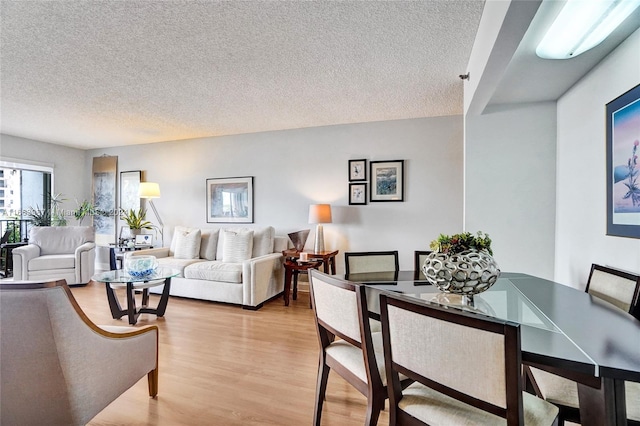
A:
0 280 158 425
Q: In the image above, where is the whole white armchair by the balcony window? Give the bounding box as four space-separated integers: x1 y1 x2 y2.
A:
13 226 96 284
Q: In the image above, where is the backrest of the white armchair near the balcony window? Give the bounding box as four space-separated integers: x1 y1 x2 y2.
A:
29 226 95 256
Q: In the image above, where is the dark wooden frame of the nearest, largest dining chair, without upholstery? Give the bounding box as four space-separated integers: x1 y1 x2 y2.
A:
380 294 524 426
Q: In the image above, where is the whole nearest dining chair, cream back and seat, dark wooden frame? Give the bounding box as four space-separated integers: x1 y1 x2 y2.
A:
380 294 558 426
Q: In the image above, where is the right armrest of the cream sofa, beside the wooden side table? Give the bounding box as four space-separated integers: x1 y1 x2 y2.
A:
242 253 283 307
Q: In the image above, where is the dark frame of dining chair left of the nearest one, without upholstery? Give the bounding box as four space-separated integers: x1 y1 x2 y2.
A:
309 269 387 426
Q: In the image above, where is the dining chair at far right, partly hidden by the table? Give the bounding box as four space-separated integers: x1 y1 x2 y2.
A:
524 263 640 426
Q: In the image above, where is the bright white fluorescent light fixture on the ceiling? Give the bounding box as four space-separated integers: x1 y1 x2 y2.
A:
536 0 640 59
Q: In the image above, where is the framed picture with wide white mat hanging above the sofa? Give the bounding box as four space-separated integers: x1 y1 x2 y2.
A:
207 176 253 223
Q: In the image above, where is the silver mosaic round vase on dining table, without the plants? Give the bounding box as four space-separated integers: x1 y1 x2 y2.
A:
422 249 500 296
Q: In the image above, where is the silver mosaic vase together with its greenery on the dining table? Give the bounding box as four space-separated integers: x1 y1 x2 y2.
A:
422 232 500 296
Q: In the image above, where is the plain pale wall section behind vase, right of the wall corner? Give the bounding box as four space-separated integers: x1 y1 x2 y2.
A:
464 103 556 278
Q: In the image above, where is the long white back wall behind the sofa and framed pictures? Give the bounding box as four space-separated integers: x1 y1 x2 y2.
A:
84 116 462 272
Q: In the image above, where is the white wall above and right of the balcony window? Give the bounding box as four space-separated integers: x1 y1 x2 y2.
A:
0 134 91 215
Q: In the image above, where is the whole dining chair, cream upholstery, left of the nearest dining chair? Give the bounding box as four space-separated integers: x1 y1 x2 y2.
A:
310 269 410 426
